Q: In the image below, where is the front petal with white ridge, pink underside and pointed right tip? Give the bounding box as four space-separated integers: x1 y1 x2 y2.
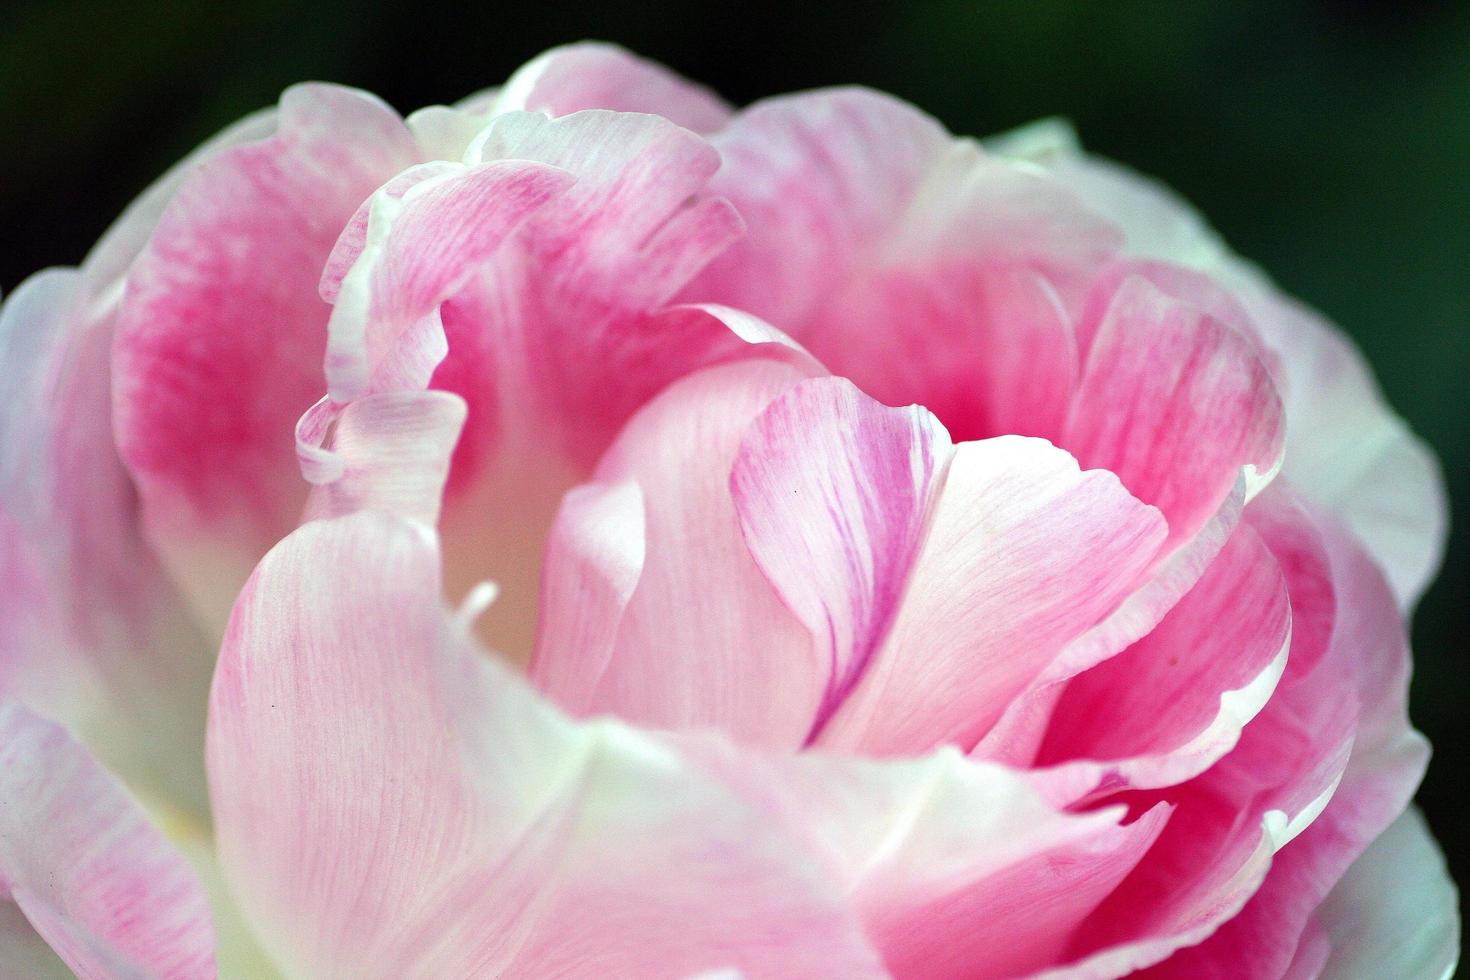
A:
688 745 1169 977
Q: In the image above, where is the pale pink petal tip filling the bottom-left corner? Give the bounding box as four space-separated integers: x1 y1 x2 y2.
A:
0 702 215 980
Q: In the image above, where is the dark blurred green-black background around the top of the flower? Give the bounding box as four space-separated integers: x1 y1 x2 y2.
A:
0 0 1470 916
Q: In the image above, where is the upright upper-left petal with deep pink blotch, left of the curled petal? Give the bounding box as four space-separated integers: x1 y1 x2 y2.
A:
113 85 416 621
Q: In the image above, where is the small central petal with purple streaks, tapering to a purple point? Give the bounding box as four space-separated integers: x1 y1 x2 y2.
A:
731 378 953 733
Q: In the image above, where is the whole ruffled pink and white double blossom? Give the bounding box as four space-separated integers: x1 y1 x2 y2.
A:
0 44 1458 979
